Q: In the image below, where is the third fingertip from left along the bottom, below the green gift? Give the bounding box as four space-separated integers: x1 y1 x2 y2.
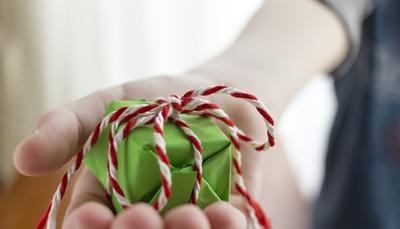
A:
164 205 211 229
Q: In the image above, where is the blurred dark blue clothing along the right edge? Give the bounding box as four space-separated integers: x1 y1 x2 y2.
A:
313 0 400 229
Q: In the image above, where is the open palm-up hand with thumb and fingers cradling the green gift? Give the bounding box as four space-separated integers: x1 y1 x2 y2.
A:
14 74 264 229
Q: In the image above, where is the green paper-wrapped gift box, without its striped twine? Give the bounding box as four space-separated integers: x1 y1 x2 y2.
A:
84 100 231 214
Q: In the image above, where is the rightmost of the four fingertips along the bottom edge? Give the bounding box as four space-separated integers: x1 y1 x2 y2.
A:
204 202 246 229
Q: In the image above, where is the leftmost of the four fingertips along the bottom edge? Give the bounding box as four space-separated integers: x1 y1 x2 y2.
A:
62 202 114 229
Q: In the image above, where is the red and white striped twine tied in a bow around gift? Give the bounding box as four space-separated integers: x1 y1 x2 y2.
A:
36 86 275 229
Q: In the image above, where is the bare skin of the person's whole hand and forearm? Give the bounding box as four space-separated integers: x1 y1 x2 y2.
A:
14 0 348 229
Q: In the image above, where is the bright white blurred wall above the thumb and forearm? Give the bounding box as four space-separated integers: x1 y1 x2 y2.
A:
32 0 262 107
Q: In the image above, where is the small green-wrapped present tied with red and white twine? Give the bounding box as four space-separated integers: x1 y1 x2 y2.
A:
36 86 275 229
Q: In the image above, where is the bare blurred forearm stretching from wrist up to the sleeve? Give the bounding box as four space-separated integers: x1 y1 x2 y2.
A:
190 0 348 116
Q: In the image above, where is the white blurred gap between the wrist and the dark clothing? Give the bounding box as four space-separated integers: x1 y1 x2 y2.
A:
277 74 337 201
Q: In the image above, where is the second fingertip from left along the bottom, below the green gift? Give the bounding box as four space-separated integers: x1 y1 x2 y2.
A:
111 204 163 229
